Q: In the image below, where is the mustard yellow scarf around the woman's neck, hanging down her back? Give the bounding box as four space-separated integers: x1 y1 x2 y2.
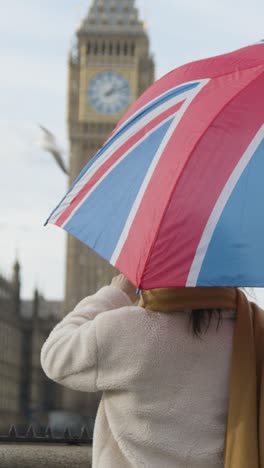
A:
139 288 264 468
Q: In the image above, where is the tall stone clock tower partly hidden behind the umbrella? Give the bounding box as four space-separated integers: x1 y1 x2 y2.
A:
65 0 154 310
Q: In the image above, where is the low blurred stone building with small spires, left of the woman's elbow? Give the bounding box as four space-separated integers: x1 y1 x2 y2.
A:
0 262 62 432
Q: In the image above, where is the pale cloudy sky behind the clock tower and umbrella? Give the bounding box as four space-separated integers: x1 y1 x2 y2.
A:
0 0 264 304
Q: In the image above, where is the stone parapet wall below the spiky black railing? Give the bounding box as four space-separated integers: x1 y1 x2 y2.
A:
0 443 92 468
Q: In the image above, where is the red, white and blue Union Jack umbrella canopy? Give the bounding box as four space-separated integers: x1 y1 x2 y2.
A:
48 41 264 289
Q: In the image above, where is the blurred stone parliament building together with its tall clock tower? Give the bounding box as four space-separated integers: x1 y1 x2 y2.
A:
0 0 154 430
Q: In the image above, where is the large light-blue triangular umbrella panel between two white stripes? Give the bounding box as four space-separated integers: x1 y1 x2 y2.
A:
65 118 173 260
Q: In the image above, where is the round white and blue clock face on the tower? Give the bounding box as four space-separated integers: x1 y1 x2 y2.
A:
88 72 131 115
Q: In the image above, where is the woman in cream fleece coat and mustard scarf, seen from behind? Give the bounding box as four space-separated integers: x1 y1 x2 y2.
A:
41 275 264 468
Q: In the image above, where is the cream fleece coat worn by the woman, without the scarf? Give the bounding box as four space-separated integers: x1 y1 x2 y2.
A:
41 286 234 468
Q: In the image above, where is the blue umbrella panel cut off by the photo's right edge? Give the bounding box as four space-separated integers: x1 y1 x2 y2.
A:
197 140 264 287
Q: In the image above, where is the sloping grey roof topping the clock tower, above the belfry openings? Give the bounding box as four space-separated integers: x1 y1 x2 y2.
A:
78 0 144 34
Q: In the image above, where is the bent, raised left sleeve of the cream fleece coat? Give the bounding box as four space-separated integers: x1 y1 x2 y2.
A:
41 286 132 392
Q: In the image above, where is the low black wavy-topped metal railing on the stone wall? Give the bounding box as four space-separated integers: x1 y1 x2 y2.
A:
0 425 92 445
